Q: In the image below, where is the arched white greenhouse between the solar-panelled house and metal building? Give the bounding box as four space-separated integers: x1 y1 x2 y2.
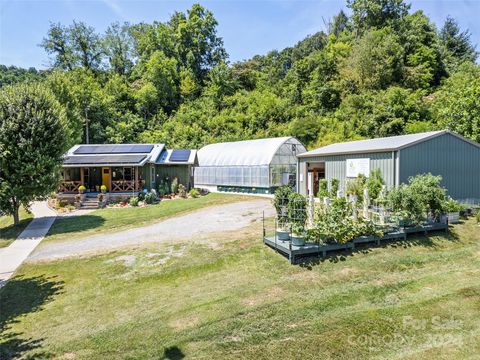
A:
195 137 306 194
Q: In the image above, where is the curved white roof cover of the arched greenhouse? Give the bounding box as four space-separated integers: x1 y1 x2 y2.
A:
198 136 305 166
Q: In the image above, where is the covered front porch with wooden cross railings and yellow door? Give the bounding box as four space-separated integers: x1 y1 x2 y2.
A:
58 166 145 194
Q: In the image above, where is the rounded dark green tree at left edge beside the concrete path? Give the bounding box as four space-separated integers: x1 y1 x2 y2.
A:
0 84 67 225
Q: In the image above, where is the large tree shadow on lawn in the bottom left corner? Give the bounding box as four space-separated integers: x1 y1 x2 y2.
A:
0 276 63 359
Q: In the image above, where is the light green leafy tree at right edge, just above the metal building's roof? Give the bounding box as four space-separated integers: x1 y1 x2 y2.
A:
433 63 480 142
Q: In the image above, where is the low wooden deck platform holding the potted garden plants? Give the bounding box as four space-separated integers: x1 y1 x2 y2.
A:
263 223 448 264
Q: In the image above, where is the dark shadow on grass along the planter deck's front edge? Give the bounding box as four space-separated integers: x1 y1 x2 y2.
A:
296 230 460 270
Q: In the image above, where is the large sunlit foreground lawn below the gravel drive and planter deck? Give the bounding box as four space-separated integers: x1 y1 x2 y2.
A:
0 219 480 359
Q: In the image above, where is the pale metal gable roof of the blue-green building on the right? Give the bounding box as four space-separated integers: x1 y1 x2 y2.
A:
298 130 480 157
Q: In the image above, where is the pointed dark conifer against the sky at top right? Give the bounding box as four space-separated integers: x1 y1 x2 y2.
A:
440 16 478 71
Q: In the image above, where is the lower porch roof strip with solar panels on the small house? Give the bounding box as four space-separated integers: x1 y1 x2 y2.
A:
63 154 147 166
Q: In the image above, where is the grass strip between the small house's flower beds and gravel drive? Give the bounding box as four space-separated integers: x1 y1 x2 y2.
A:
45 193 252 241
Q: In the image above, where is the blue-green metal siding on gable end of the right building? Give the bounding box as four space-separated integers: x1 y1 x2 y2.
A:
400 133 480 201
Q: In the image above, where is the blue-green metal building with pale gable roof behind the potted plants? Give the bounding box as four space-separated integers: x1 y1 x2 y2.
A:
297 130 480 201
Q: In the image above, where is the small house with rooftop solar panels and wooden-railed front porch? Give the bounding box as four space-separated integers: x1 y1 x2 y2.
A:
59 144 197 198
